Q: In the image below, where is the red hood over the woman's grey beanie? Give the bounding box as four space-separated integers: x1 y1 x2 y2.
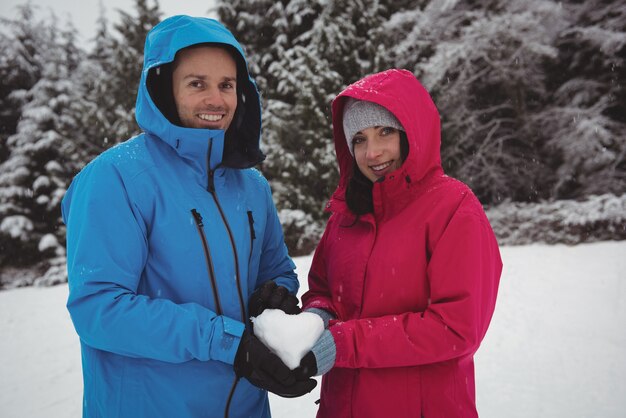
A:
332 69 442 192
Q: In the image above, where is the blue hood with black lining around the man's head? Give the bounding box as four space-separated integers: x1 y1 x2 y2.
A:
135 15 264 168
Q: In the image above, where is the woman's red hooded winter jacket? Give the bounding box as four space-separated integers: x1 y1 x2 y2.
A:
303 70 502 418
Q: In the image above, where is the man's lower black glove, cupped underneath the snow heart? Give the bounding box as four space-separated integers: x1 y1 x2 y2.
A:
234 331 317 398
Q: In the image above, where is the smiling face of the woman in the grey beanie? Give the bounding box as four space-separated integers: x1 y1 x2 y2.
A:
352 126 402 182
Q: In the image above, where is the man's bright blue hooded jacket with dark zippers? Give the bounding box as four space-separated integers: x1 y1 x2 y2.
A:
62 16 298 418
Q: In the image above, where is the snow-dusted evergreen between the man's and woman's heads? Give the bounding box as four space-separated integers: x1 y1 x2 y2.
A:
218 0 389 254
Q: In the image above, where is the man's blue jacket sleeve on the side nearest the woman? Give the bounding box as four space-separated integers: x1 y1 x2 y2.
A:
256 181 300 295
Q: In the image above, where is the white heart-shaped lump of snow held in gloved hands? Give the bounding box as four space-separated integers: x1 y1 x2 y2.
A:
251 309 324 370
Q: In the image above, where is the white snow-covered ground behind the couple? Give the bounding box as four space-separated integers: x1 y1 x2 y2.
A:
0 241 626 418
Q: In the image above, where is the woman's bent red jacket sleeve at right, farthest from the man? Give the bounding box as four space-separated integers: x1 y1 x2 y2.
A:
330 198 502 368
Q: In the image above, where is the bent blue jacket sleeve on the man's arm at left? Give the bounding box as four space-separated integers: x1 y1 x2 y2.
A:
62 160 244 364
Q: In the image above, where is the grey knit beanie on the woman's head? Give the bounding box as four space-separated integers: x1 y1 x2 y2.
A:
343 97 404 156
